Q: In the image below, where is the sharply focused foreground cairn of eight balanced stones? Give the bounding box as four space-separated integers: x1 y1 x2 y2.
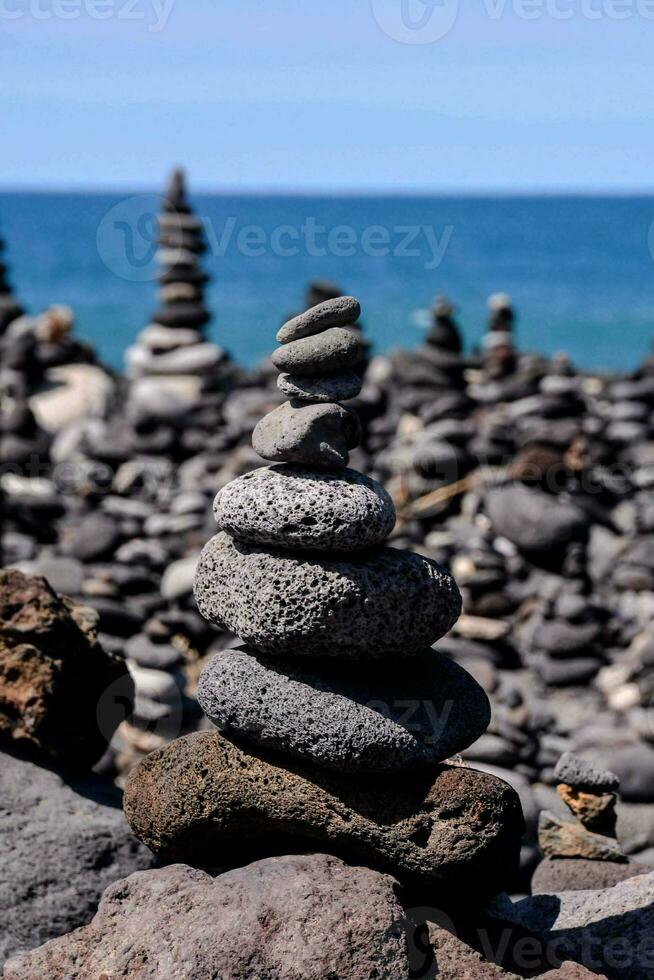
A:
124 297 523 898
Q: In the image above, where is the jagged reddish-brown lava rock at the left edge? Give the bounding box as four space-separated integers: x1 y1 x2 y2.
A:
0 571 134 769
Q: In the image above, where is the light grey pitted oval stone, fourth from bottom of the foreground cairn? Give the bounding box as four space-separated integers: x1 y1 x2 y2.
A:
213 464 395 552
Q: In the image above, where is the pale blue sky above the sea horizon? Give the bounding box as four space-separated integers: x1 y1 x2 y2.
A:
0 0 654 192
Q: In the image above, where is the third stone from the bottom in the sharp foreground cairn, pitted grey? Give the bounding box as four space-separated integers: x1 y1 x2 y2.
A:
195 532 461 659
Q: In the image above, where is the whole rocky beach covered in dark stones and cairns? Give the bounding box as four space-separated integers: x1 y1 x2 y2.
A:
0 180 654 980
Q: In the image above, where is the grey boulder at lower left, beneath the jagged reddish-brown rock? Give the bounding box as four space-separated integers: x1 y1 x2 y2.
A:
0 754 154 964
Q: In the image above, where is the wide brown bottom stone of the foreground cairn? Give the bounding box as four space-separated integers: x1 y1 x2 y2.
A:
124 731 523 901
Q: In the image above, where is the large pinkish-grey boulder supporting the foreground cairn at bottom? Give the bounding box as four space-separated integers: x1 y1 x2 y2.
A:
5 854 408 980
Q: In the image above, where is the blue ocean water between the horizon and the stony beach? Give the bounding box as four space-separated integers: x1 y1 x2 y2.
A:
0 193 654 370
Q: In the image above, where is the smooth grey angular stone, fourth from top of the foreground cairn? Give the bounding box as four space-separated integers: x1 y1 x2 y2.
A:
252 402 361 469
